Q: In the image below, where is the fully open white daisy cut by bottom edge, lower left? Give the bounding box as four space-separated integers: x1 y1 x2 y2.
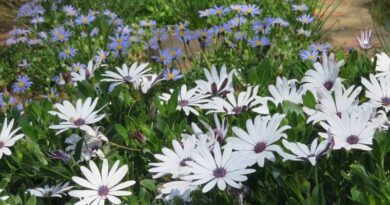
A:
69 160 135 205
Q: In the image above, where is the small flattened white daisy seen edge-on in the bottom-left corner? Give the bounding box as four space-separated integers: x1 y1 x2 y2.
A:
27 182 72 198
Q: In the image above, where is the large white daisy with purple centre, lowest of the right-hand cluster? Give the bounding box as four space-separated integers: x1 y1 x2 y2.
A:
319 109 378 150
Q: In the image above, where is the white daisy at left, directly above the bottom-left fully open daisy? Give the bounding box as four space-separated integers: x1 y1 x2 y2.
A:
49 98 105 135
